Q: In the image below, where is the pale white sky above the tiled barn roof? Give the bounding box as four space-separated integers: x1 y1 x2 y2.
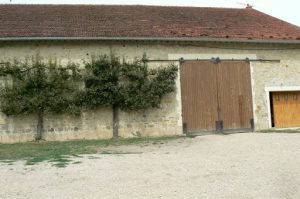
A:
0 0 300 26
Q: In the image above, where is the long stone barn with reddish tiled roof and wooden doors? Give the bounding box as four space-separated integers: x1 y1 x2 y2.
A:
0 5 300 142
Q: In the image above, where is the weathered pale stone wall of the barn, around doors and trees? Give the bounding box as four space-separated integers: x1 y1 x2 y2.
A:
0 41 300 142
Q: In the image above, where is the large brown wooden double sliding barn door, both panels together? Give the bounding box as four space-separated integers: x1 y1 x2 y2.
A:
180 61 252 132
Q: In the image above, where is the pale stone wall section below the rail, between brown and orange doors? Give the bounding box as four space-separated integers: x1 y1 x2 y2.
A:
251 60 300 130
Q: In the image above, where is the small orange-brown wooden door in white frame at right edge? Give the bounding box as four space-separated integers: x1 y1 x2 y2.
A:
272 91 300 128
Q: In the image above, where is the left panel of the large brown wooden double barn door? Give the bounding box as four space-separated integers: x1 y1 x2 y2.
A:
180 61 218 132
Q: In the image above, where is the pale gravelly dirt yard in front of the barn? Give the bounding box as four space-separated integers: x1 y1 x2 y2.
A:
0 133 300 199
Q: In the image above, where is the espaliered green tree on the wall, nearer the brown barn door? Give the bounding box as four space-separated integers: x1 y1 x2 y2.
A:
83 55 178 138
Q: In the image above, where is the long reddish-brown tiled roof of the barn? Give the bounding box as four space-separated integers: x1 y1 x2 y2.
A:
0 4 300 40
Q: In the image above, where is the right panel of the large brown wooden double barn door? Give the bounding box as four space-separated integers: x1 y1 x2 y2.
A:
218 61 253 129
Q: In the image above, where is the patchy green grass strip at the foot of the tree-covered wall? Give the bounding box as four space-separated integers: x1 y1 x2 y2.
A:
0 136 180 167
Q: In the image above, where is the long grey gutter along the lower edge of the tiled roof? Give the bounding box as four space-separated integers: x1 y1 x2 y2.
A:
0 37 300 44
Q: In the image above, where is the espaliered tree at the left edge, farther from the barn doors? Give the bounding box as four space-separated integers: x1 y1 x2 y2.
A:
0 56 80 140
